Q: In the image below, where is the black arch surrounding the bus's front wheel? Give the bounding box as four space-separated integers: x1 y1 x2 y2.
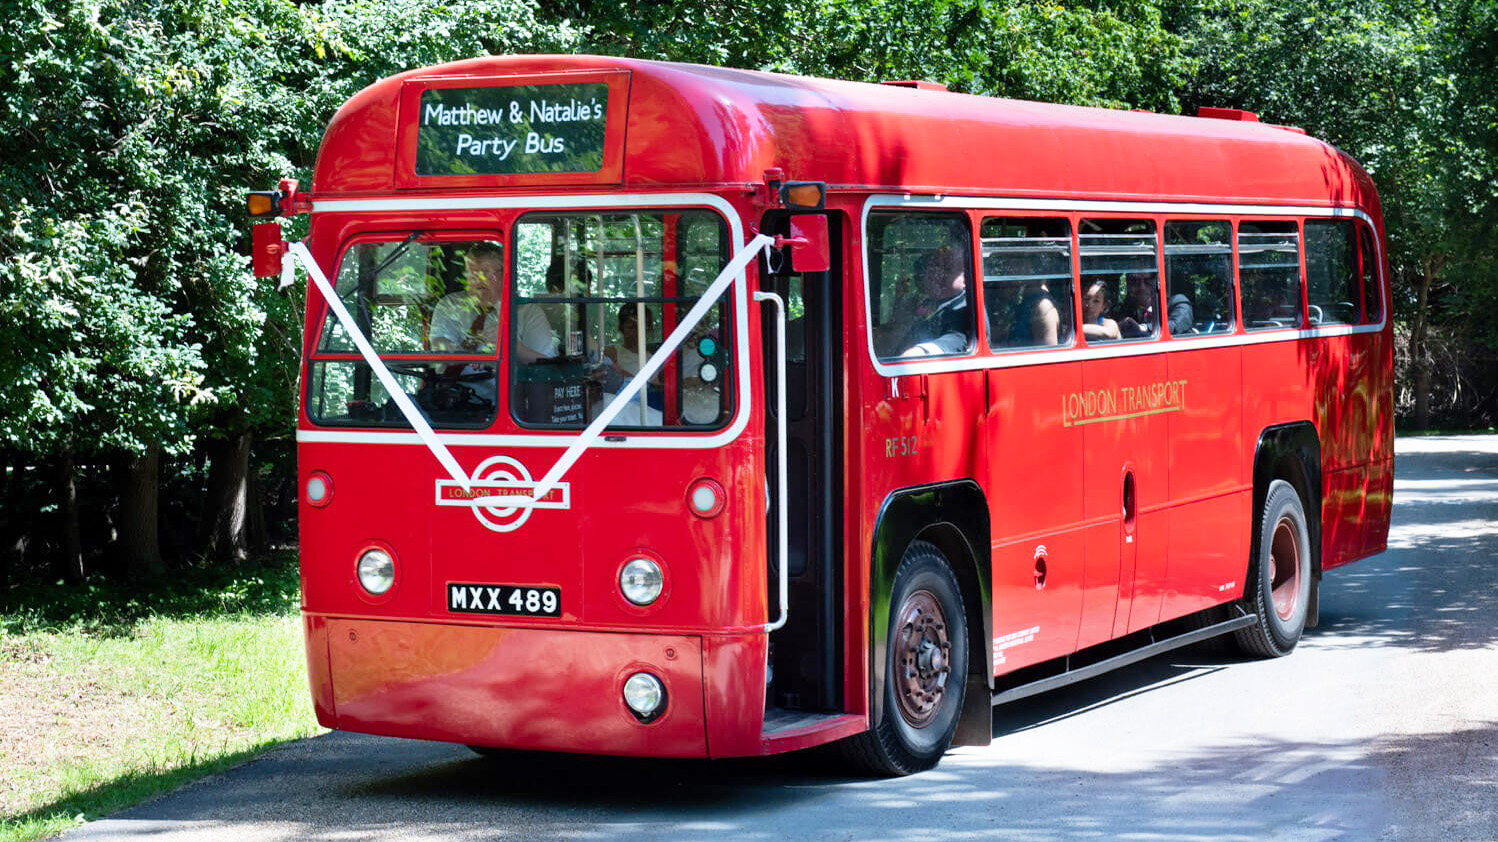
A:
869 479 993 745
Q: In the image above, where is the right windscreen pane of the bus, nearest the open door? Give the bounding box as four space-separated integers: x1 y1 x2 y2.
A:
508 210 733 428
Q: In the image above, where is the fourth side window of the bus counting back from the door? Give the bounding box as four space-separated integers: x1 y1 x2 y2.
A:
1164 220 1233 337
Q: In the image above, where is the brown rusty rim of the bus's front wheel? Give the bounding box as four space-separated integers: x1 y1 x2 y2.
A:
894 590 951 728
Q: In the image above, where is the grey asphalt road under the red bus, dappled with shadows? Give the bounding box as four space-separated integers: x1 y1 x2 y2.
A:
66 437 1498 842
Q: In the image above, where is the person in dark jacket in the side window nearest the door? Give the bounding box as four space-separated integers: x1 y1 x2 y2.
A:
879 244 972 357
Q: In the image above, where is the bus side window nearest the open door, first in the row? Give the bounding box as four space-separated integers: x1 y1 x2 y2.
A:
869 211 975 360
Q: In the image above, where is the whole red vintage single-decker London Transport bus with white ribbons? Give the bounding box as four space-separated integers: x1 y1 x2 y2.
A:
250 55 1393 775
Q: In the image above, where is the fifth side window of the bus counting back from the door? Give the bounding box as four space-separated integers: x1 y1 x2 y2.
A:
1237 222 1300 330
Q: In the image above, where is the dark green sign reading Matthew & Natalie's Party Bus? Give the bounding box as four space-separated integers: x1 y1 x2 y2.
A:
416 82 608 175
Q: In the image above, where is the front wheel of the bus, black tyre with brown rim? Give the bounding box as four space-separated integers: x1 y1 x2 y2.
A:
842 541 968 775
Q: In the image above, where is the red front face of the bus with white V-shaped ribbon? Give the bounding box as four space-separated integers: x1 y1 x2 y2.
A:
292 57 774 757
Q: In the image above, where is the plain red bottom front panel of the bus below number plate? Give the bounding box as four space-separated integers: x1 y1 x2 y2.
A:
306 614 709 757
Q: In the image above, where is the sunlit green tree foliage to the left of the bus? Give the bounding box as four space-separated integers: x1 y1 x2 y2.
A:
0 0 571 455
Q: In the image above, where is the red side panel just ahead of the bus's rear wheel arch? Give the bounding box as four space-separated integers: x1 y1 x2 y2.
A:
1159 342 1252 620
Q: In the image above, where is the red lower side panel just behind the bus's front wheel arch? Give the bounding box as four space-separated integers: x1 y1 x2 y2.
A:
981 364 1084 673
